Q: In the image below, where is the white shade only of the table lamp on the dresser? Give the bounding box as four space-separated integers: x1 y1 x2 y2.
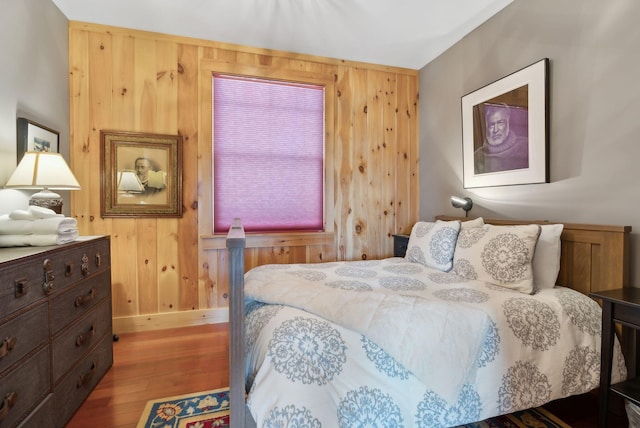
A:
5 152 80 190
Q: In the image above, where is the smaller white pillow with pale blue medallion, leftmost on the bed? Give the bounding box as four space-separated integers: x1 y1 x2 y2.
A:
405 220 460 272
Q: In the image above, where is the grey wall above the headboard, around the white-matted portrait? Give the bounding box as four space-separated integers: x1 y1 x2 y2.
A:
420 0 640 286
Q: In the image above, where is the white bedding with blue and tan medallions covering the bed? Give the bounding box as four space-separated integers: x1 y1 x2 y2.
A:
245 258 626 427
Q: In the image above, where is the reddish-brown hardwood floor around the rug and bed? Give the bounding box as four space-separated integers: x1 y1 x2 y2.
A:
67 324 628 428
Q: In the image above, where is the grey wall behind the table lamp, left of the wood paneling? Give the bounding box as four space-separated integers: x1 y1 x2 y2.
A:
0 0 69 214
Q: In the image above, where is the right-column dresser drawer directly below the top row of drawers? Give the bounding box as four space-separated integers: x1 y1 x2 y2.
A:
51 270 111 334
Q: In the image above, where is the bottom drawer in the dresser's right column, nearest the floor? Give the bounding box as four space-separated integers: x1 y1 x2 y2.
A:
54 336 113 427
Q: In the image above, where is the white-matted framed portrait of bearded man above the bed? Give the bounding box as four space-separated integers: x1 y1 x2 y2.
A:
462 58 549 188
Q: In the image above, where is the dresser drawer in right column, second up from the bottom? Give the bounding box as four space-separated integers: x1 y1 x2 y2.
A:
52 299 113 383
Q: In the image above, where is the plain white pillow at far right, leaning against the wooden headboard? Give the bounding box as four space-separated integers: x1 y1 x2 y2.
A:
533 224 564 290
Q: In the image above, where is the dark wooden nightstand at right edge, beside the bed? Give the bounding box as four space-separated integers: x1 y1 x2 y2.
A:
590 287 640 427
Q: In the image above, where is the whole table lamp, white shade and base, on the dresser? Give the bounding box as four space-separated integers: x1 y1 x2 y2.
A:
5 152 80 214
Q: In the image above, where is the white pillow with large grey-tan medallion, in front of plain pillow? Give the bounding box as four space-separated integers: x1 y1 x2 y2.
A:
453 224 540 294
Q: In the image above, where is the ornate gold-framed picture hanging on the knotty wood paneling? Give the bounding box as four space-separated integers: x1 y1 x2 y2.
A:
100 130 182 218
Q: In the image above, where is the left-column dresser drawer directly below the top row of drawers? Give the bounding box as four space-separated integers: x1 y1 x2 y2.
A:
0 302 49 373
